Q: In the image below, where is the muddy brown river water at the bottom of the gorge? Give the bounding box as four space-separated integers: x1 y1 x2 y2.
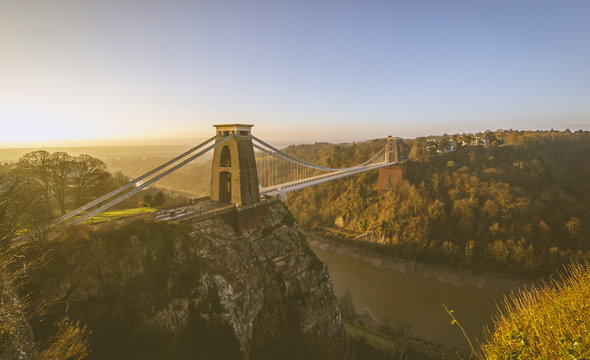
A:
312 246 506 349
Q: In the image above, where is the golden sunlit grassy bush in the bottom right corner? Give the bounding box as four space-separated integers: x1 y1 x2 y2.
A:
481 264 590 360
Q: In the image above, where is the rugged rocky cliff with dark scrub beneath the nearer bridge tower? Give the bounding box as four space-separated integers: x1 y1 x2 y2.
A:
25 202 350 359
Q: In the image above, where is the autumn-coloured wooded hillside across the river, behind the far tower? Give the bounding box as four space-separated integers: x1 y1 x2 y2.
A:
288 130 590 274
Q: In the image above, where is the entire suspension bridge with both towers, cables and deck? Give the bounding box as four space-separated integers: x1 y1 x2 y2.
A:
52 124 408 231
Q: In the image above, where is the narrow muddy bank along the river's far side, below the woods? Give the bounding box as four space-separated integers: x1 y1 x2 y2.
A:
304 231 526 290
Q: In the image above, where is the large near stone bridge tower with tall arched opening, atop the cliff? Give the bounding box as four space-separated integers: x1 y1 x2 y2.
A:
211 124 260 206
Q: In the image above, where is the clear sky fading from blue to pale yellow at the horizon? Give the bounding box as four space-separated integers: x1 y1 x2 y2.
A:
0 0 590 147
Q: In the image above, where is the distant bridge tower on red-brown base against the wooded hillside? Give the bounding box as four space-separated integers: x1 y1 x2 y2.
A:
377 135 408 191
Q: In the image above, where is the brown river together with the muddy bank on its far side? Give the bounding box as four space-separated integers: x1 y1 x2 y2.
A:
307 234 520 349
